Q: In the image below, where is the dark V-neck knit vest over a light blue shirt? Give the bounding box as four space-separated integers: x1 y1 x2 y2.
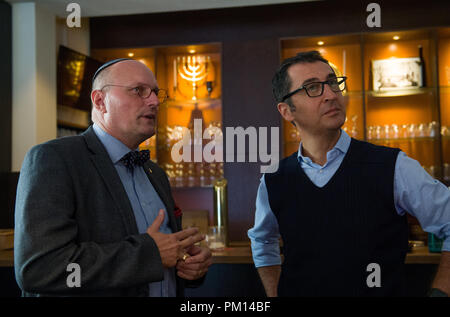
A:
265 139 408 296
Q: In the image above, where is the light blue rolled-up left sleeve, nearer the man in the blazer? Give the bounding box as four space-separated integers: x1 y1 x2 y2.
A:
248 176 281 267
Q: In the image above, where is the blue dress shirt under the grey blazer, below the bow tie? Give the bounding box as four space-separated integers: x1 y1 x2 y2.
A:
93 124 176 297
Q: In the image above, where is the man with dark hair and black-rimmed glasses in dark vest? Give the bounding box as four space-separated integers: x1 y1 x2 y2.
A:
248 51 450 296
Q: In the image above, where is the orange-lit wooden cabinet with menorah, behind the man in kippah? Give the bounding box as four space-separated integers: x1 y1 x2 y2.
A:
92 44 223 188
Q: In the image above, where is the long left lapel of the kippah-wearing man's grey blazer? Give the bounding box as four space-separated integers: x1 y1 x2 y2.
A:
84 126 138 234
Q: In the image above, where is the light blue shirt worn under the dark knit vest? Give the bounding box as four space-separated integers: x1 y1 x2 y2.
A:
248 130 450 267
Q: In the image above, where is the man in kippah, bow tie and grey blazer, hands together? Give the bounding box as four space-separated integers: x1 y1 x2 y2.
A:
14 59 212 297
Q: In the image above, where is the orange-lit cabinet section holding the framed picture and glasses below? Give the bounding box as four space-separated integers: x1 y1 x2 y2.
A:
363 30 443 180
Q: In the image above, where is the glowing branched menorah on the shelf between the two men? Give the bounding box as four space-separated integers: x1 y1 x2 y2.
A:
174 56 212 101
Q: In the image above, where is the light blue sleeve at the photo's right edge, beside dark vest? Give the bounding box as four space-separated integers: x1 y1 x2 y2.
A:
394 152 450 251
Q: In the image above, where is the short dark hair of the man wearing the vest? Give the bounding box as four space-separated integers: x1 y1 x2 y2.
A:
272 51 329 110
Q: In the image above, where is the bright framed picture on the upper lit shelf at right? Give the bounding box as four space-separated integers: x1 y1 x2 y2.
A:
372 57 423 96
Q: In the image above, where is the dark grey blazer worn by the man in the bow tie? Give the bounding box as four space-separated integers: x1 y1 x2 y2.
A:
14 127 197 296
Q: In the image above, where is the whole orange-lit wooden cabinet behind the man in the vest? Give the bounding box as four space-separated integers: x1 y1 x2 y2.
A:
281 28 450 183
